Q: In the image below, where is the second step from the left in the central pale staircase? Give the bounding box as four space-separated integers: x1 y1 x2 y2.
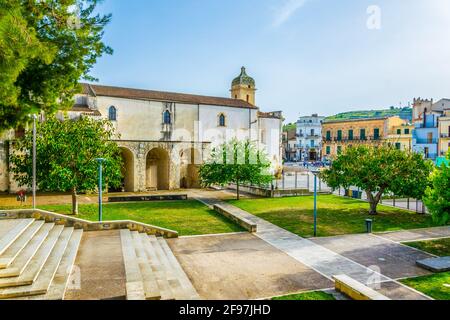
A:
131 231 161 300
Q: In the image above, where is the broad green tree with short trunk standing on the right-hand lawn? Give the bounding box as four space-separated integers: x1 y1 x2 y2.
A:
321 145 432 215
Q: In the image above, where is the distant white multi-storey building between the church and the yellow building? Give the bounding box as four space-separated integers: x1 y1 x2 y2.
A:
297 114 325 161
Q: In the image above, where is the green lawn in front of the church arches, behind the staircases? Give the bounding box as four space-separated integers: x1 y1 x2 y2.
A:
39 200 243 236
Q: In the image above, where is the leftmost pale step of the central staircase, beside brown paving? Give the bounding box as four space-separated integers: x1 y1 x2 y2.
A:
120 229 145 300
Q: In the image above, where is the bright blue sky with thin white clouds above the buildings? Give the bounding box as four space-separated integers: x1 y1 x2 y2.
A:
91 0 450 121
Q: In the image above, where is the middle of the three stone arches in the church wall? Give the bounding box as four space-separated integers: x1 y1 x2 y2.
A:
145 148 170 190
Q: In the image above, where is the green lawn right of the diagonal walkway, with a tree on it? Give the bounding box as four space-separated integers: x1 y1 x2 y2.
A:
229 195 436 237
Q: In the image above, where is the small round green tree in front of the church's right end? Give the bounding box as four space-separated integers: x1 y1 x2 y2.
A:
199 139 273 200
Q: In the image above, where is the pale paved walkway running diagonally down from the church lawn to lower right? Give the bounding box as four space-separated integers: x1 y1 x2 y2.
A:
192 191 436 299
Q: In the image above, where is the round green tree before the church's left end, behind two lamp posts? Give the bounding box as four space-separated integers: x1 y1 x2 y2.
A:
10 117 123 214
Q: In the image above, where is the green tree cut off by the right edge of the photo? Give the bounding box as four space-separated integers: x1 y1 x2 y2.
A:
424 152 450 225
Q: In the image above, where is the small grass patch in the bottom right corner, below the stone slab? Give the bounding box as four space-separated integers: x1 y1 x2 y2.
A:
401 272 450 300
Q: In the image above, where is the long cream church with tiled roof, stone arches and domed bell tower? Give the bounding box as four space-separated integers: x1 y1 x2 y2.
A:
0 68 283 192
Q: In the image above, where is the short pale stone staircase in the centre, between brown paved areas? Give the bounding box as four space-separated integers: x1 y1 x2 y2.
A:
120 229 200 300
